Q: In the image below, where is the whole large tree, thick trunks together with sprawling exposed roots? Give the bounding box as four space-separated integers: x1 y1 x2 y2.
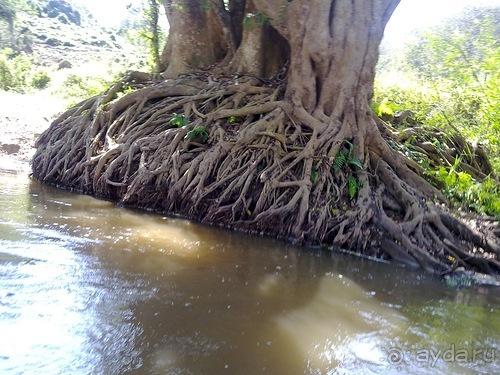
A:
33 0 500 273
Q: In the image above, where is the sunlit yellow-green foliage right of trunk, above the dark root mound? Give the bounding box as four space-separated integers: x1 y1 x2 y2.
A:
372 6 500 181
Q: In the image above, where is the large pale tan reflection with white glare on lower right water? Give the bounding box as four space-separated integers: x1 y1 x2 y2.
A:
276 273 407 370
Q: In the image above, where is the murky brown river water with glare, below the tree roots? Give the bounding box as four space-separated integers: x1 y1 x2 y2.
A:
0 171 500 374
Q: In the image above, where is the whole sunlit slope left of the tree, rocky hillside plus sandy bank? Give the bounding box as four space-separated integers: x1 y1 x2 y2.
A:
0 0 147 164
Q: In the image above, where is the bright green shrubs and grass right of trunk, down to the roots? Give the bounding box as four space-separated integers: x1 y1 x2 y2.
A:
372 7 500 218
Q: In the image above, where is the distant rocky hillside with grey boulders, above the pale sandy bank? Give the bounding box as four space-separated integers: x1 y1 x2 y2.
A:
0 0 147 92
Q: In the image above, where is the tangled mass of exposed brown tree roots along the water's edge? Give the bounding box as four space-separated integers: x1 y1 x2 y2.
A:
33 74 500 280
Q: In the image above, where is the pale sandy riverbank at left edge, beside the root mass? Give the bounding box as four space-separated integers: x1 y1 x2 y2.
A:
0 91 66 171
